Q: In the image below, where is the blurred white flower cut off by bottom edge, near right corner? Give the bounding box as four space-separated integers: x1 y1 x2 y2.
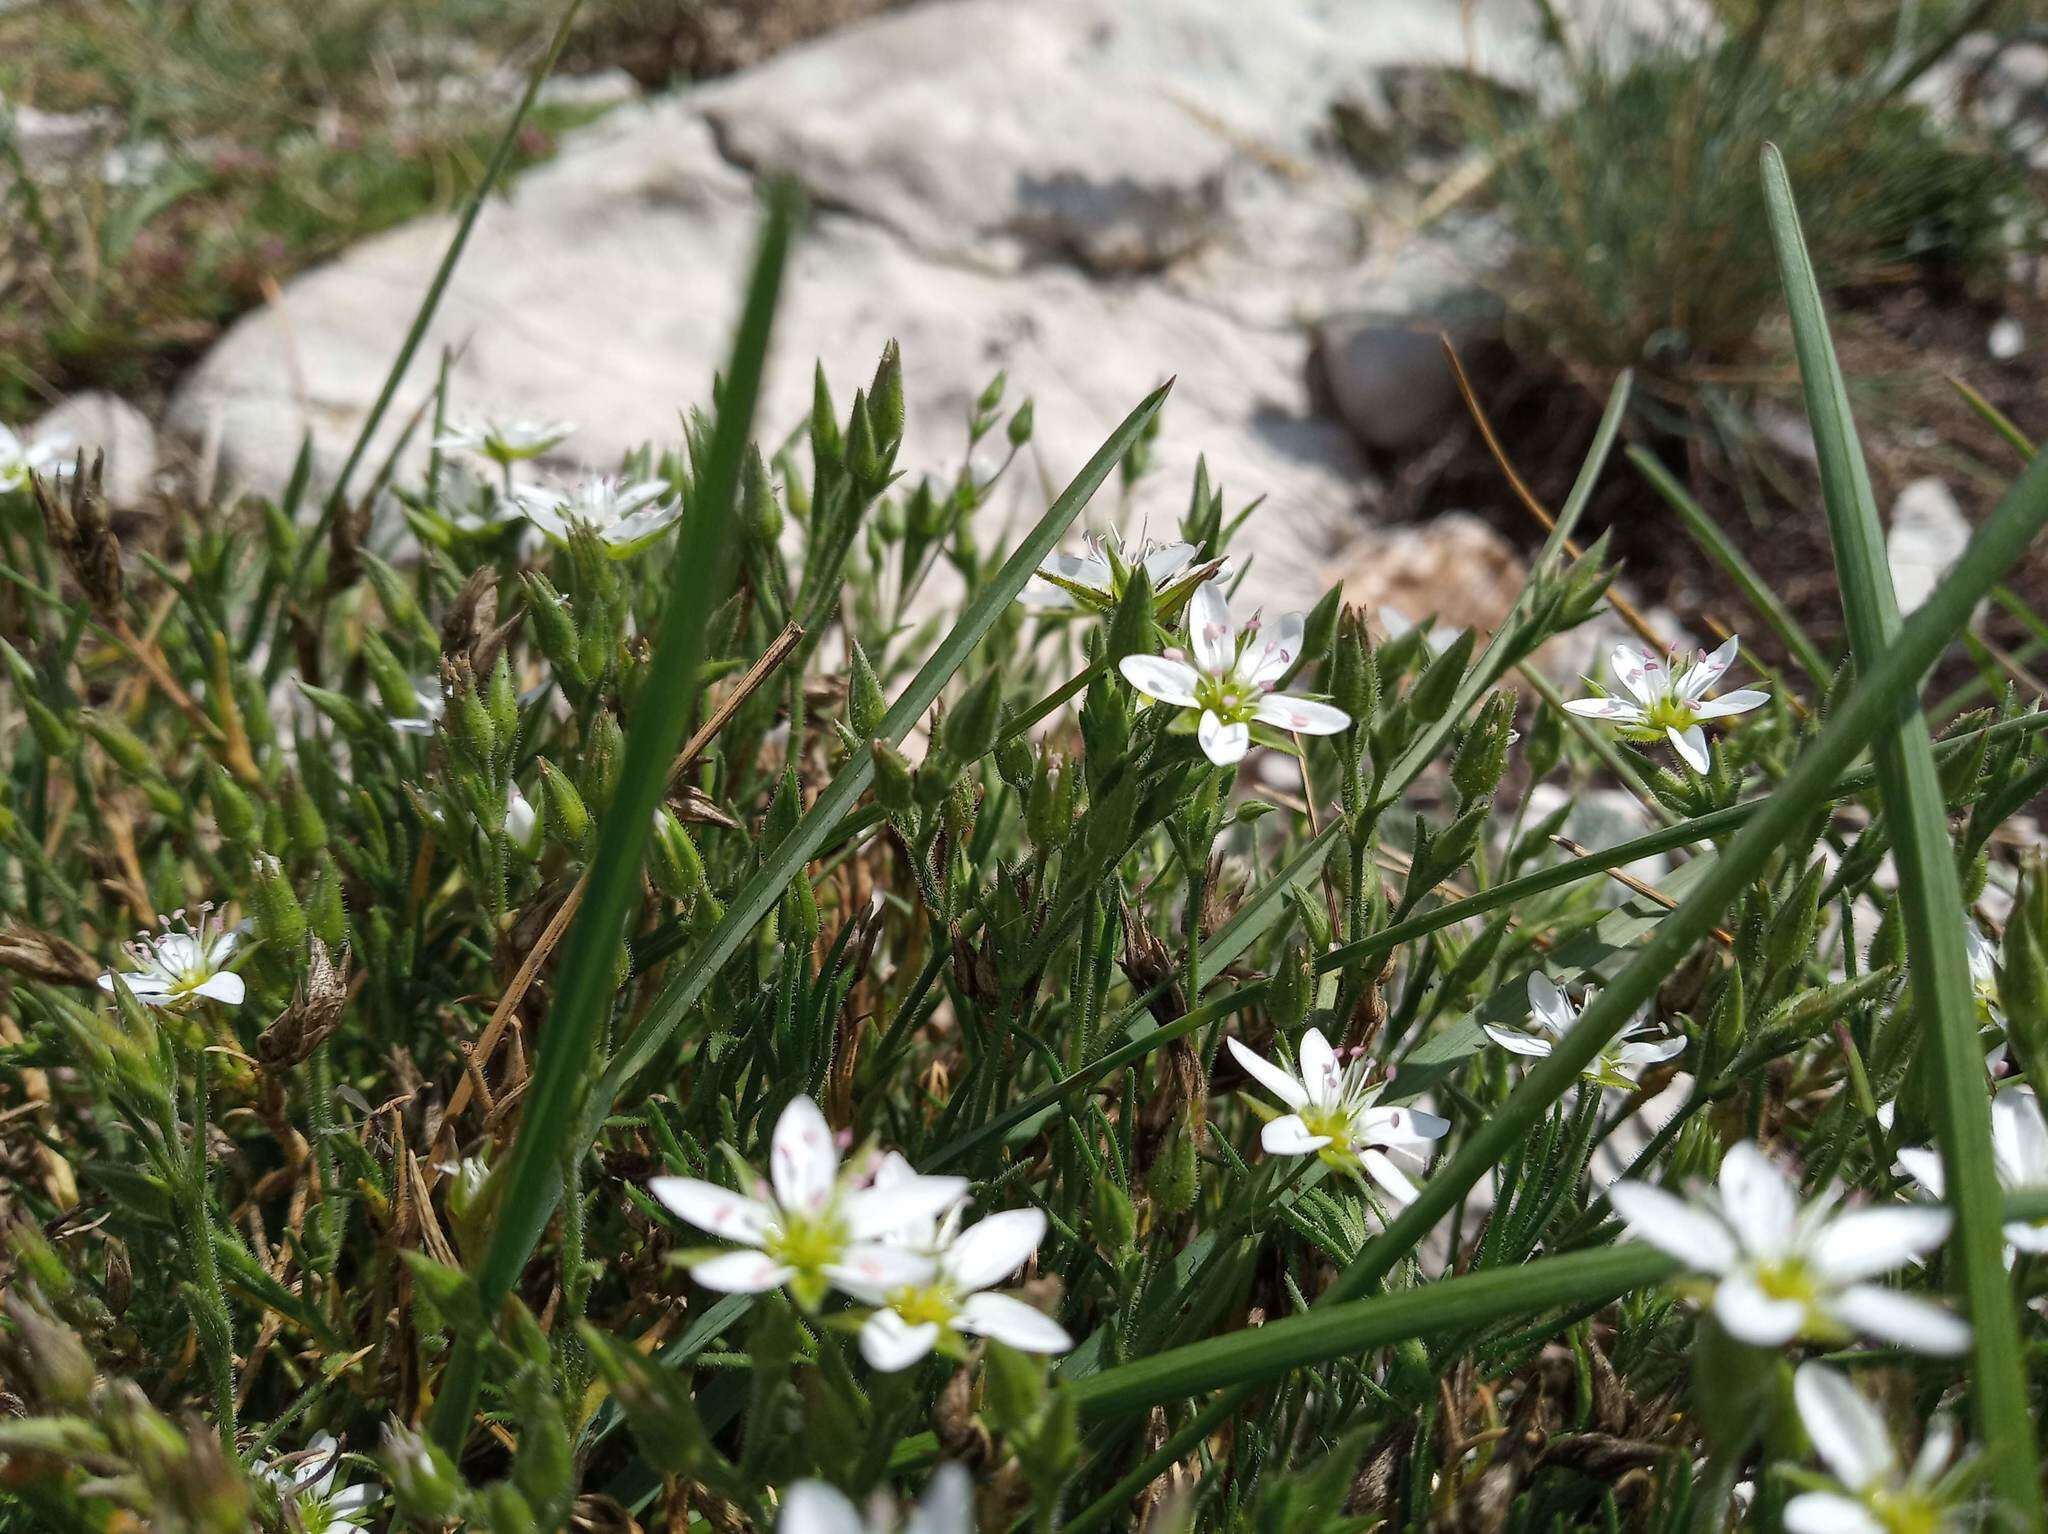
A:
1784 1364 1970 1534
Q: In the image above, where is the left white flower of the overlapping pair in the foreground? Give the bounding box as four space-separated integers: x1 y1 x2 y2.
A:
647 1098 967 1309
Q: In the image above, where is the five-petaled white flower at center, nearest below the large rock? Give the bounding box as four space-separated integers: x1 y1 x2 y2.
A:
1118 582 1352 766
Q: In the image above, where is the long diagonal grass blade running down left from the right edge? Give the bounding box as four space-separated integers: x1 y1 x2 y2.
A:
1331 430 2048 1301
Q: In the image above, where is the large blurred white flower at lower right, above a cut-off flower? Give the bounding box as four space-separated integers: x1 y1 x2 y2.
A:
1608 1141 1970 1354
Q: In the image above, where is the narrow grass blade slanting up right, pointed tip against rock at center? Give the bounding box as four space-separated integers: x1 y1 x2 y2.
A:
590 383 1174 1097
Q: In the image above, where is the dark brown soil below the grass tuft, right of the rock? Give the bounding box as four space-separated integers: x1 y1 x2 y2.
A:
1384 283 2048 700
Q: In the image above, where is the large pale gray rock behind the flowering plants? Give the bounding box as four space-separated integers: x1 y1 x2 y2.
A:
170 0 1679 602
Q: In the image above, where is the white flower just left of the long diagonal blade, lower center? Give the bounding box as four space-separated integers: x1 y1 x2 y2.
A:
1229 1028 1450 1204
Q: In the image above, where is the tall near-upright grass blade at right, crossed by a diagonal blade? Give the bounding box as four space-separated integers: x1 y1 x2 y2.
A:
1763 145 2048 1530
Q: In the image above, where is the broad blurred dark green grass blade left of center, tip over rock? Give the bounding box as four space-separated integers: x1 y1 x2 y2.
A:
434 186 797 1452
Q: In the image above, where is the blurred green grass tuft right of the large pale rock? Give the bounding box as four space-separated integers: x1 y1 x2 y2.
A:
1487 6 2030 379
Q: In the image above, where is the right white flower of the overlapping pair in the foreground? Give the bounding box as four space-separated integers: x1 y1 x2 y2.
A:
840 1151 1073 1374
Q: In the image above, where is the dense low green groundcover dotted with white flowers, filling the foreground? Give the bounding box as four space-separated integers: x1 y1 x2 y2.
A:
0 146 2048 1534
